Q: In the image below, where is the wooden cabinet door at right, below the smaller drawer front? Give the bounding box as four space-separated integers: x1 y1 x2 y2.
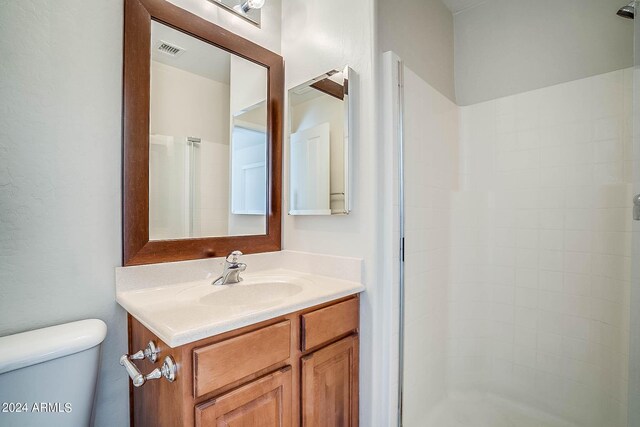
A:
302 335 358 427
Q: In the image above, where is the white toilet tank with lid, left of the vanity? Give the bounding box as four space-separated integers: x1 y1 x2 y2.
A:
0 319 107 427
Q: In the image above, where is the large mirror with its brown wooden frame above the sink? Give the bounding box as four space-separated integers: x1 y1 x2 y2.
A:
122 0 284 266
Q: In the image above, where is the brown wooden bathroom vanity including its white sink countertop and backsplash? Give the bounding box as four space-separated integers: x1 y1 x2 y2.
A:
116 260 364 427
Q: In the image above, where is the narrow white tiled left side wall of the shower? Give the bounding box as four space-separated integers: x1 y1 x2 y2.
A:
403 67 458 426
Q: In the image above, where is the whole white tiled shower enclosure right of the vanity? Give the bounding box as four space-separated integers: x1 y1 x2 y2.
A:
384 4 640 427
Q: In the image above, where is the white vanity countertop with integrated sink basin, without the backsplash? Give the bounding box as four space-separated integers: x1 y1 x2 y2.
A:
116 269 364 347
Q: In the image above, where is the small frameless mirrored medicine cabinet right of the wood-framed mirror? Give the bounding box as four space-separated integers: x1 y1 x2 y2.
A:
289 67 350 215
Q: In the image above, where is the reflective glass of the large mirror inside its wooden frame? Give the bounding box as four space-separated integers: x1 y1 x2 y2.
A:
149 21 269 240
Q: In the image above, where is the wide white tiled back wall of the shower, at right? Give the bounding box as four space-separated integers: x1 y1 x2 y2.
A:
447 70 632 427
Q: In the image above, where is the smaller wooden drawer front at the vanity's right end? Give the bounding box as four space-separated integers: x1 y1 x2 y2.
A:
300 298 360 351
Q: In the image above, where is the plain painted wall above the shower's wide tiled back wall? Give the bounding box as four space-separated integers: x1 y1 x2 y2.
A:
454 0 633 105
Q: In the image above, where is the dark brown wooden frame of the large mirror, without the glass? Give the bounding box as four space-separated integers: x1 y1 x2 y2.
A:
122 0 284 266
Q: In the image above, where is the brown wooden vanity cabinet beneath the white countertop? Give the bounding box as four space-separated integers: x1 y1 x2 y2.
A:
129 295 359 427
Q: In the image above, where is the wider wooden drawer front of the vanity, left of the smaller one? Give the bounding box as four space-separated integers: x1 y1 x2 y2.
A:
193 320 291 397
